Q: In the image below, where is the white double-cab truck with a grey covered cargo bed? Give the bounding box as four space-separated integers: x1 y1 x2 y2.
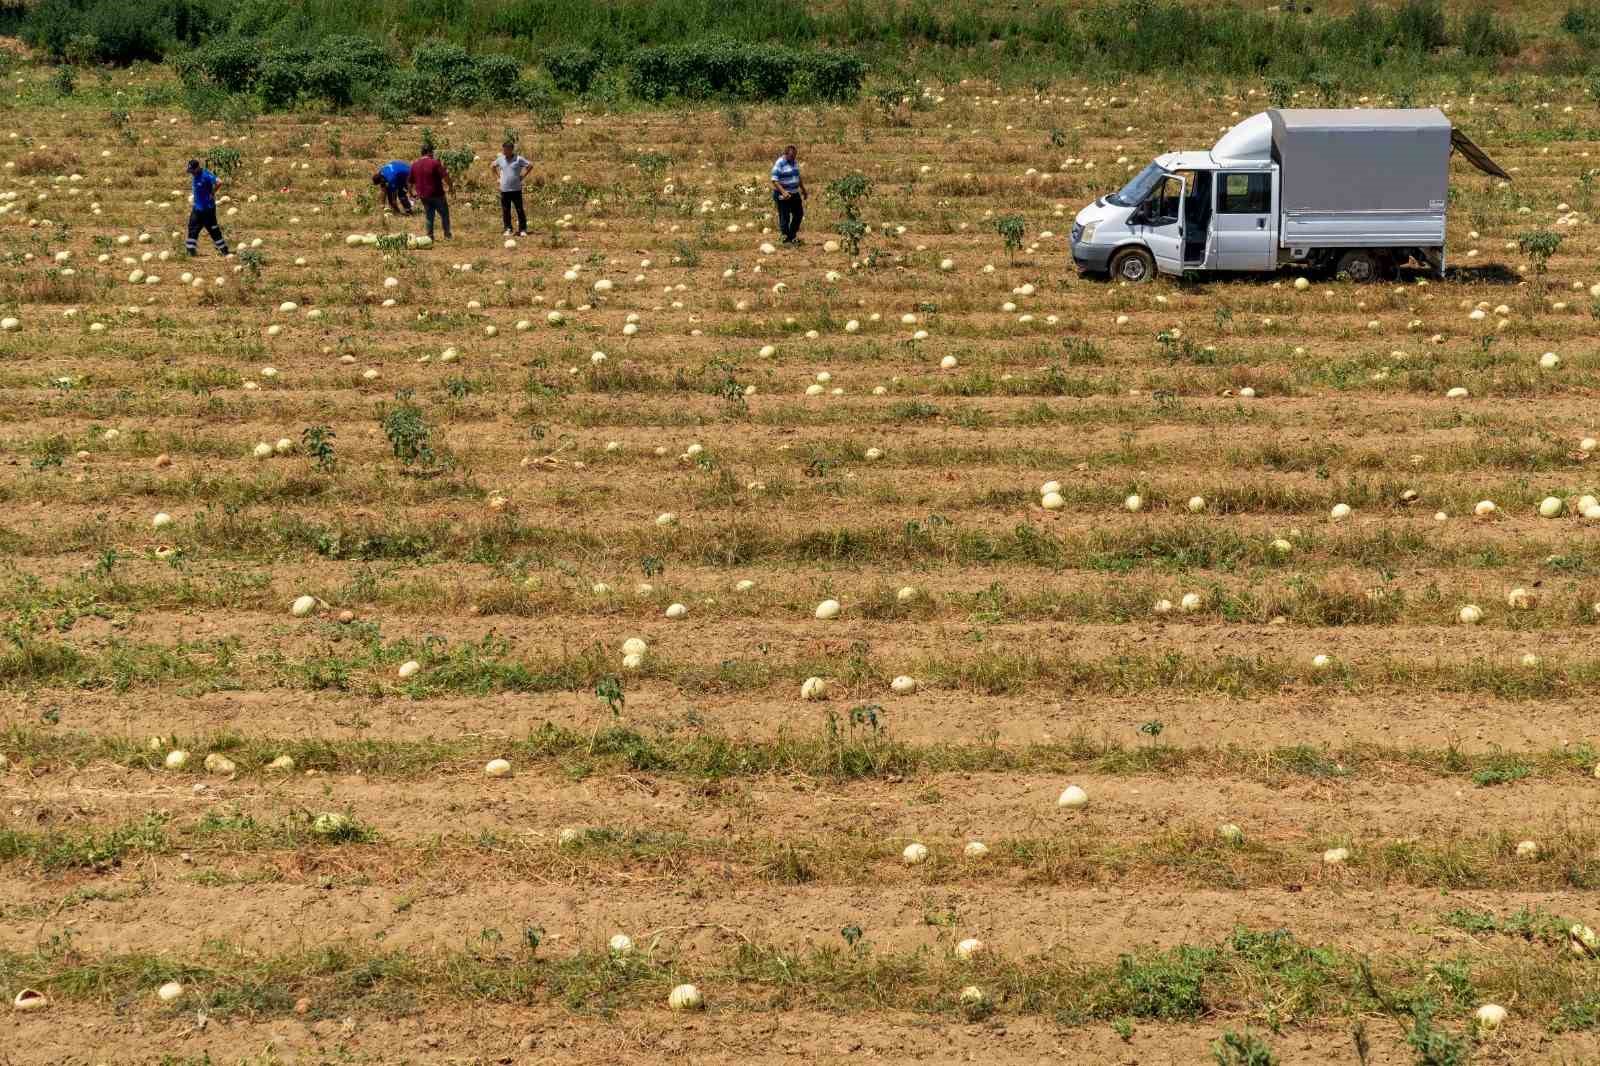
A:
1072 107 1510 282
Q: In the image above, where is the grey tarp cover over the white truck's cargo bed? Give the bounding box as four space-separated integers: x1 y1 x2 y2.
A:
1267 107 1451 214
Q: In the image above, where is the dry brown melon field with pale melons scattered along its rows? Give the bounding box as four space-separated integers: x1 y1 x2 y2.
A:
0 43 1600 1066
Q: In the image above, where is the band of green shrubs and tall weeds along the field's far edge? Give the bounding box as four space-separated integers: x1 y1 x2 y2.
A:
25 0 1548 110
